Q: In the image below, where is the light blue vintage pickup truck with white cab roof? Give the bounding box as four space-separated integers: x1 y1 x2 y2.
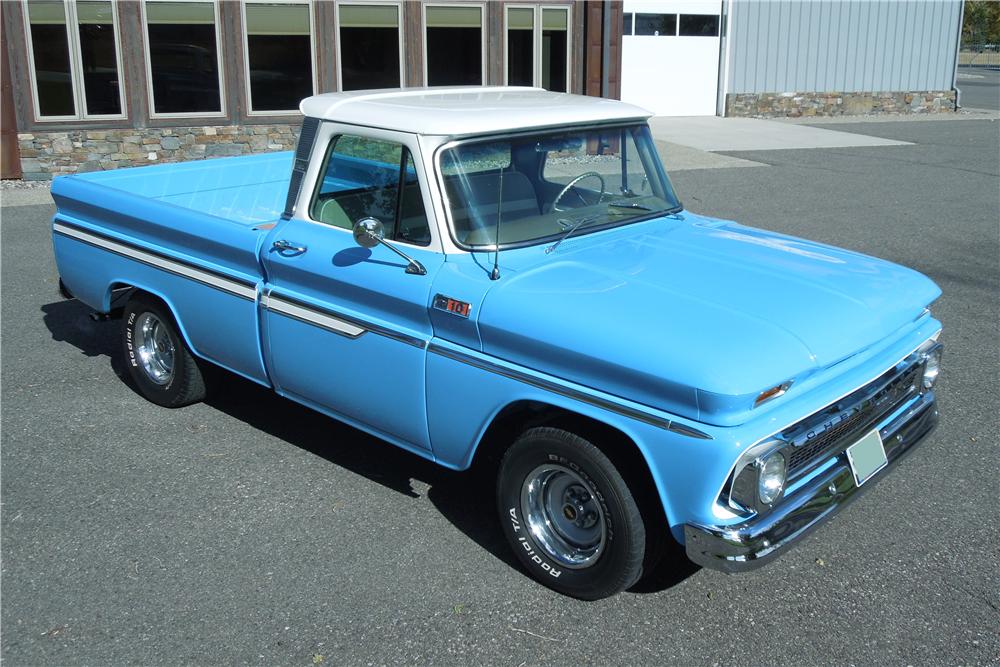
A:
52 88 941 599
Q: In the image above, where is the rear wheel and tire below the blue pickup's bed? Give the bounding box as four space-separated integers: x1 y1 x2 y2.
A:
122 294 205 408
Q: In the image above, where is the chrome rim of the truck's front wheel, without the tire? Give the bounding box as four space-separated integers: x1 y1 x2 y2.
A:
521 464 607 569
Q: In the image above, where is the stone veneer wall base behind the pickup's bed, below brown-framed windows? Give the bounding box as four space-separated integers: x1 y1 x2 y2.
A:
17 125 299 181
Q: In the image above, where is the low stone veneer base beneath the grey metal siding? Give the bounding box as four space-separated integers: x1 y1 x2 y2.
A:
726 90 955 118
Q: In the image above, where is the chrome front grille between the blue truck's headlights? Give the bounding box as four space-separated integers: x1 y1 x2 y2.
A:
783 364 922 478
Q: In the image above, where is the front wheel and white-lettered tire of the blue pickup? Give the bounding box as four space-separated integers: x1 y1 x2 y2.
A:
497 428 646 600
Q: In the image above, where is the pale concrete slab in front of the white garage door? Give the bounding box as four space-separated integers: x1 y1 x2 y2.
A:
649 116 909 152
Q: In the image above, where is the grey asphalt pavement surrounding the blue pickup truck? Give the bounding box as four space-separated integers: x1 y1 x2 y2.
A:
0 120 1000 666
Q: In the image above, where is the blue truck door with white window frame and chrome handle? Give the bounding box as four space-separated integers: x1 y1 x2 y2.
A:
261 130 444 449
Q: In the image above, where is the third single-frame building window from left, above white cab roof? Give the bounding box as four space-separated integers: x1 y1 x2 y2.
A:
337 4 403 90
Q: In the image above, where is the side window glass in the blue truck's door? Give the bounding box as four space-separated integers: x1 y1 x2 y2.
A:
310 134 431 245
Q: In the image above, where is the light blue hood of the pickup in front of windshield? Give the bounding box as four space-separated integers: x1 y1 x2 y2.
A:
479 214 940 424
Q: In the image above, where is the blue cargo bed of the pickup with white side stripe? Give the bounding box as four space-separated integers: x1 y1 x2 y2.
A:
52 152 292 383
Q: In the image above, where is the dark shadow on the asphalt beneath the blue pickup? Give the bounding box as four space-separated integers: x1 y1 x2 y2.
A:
41 300 698 593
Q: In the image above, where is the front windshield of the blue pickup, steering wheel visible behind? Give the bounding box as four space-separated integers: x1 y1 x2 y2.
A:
440 124 680 249
